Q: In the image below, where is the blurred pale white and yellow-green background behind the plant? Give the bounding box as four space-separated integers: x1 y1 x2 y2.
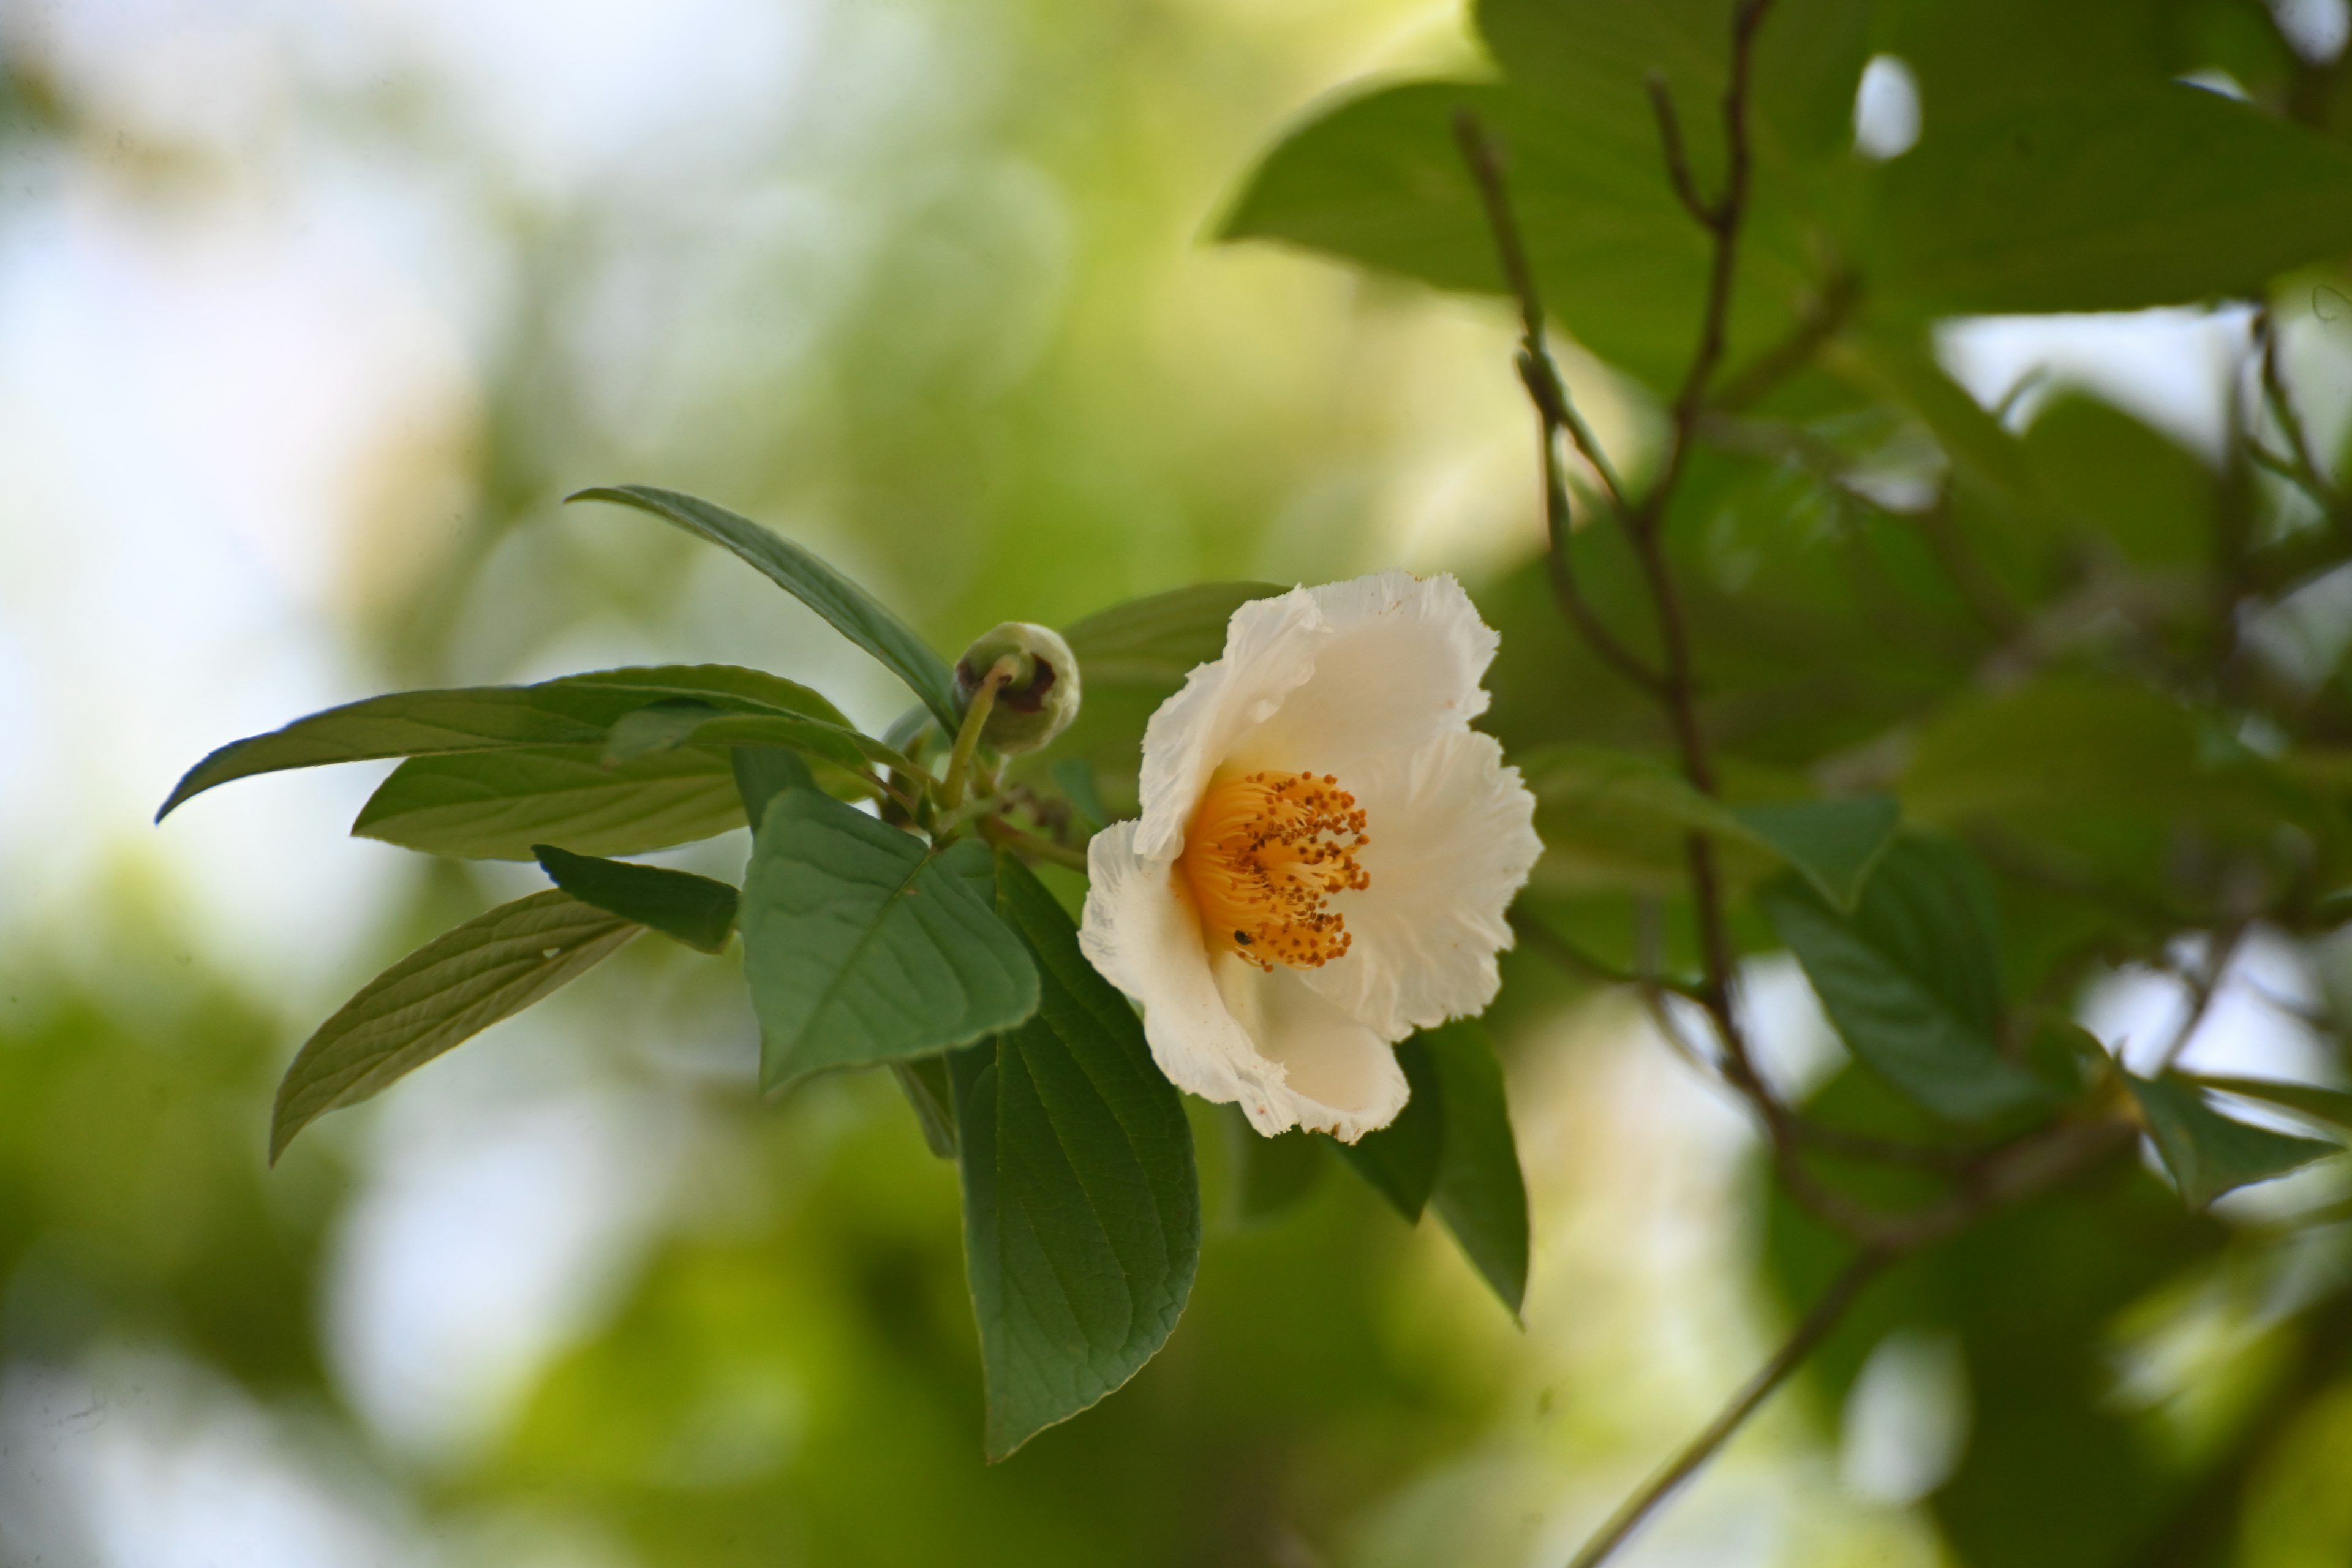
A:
0 0 2352 1568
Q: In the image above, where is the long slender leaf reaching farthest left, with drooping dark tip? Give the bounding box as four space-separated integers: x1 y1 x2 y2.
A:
155 665 849 823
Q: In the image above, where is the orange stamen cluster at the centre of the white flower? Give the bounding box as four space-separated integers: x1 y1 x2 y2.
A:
1176 774 1371 971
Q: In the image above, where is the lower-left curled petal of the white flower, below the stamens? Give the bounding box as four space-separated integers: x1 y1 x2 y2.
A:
1077 823 1409 1142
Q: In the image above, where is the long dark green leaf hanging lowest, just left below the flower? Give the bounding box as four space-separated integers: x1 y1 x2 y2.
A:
962 856 1199 1460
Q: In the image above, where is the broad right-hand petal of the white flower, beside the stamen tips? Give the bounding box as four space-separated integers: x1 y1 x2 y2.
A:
1303 731 1543 1039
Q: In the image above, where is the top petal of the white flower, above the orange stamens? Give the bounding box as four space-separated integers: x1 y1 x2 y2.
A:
1223 571 1501 790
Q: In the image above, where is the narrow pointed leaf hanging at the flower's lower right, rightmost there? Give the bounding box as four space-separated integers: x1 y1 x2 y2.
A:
1406 1018 1529 1316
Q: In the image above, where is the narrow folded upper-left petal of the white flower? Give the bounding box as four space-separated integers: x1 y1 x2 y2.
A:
1136 588 1331 861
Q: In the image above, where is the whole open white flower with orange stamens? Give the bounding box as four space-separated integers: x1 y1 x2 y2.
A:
1077 571 1543 1142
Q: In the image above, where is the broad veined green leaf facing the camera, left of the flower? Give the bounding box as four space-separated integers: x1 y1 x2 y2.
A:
741 788 1037 1088
